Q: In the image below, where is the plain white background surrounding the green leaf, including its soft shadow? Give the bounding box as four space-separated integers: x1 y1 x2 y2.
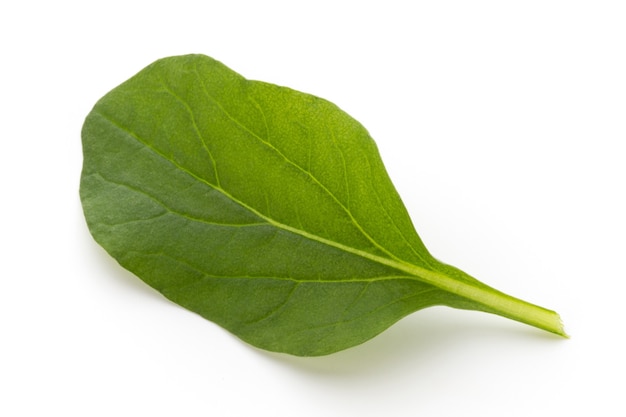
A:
0 0 626 417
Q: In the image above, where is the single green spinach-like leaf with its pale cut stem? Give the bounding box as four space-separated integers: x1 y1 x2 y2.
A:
80 55 565 356
